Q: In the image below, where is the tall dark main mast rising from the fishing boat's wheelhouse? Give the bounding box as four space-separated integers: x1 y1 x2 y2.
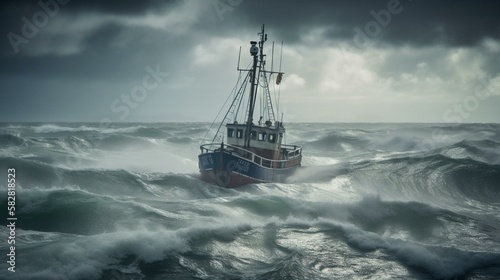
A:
245 24 267 149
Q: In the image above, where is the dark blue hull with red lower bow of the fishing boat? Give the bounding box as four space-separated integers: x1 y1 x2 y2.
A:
198 149 300 188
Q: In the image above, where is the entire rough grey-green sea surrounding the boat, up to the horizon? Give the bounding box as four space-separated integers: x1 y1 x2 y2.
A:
0 123 500 280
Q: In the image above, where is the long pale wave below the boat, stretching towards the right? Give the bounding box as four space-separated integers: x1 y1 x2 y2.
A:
223 195 450 244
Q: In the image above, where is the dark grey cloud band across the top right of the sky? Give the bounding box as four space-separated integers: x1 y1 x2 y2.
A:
227 0 500 80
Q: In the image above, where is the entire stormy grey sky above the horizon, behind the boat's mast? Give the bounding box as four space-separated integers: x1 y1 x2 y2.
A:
0 0 500 123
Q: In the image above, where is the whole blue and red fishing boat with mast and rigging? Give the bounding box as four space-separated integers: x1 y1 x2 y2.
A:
198 25 302 188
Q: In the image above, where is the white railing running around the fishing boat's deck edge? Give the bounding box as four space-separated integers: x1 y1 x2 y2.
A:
200 143 302 168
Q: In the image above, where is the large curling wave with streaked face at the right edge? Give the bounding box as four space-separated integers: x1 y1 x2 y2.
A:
350 154 500 205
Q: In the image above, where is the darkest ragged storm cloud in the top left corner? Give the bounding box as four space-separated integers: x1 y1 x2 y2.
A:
0 0 182 57
